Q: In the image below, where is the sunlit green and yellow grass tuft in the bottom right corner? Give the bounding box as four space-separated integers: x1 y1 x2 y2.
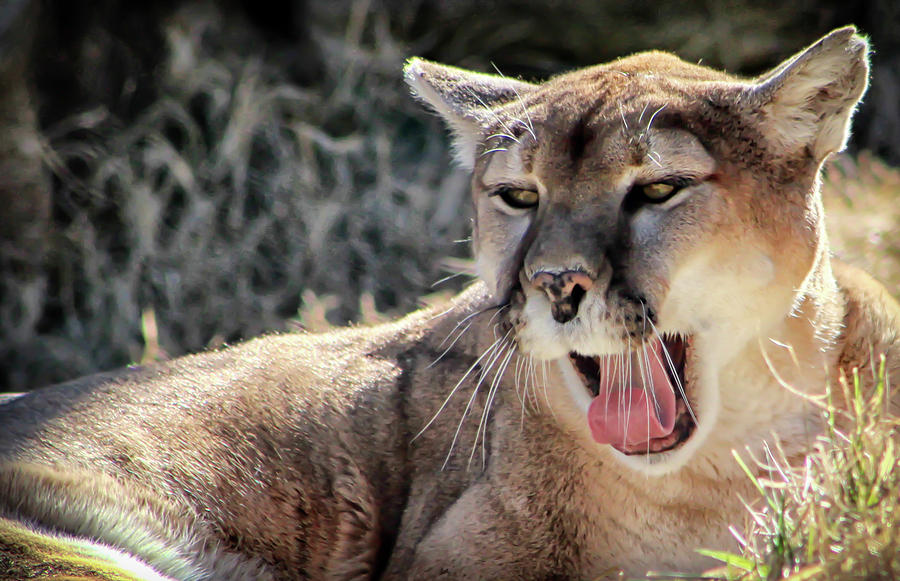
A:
701 359 900 581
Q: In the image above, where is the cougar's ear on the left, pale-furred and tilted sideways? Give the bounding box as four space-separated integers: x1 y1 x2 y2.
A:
403 58 536 169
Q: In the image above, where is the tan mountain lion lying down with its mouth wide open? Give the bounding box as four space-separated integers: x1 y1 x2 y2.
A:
0 28 900 580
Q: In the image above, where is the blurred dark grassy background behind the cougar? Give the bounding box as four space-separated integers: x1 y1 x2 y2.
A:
0 0 900 391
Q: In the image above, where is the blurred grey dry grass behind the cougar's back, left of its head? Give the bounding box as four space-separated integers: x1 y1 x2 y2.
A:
0 3 469 390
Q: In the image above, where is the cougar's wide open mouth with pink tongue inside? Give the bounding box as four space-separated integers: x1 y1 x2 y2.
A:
569 335 697 455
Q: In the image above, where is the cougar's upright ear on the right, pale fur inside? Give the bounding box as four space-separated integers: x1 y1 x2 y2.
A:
745 26 869 161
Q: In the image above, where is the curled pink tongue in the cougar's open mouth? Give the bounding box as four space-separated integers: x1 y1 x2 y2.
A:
588 340 675 451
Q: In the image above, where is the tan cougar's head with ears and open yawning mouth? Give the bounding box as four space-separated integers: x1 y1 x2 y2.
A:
407 29 867 474
